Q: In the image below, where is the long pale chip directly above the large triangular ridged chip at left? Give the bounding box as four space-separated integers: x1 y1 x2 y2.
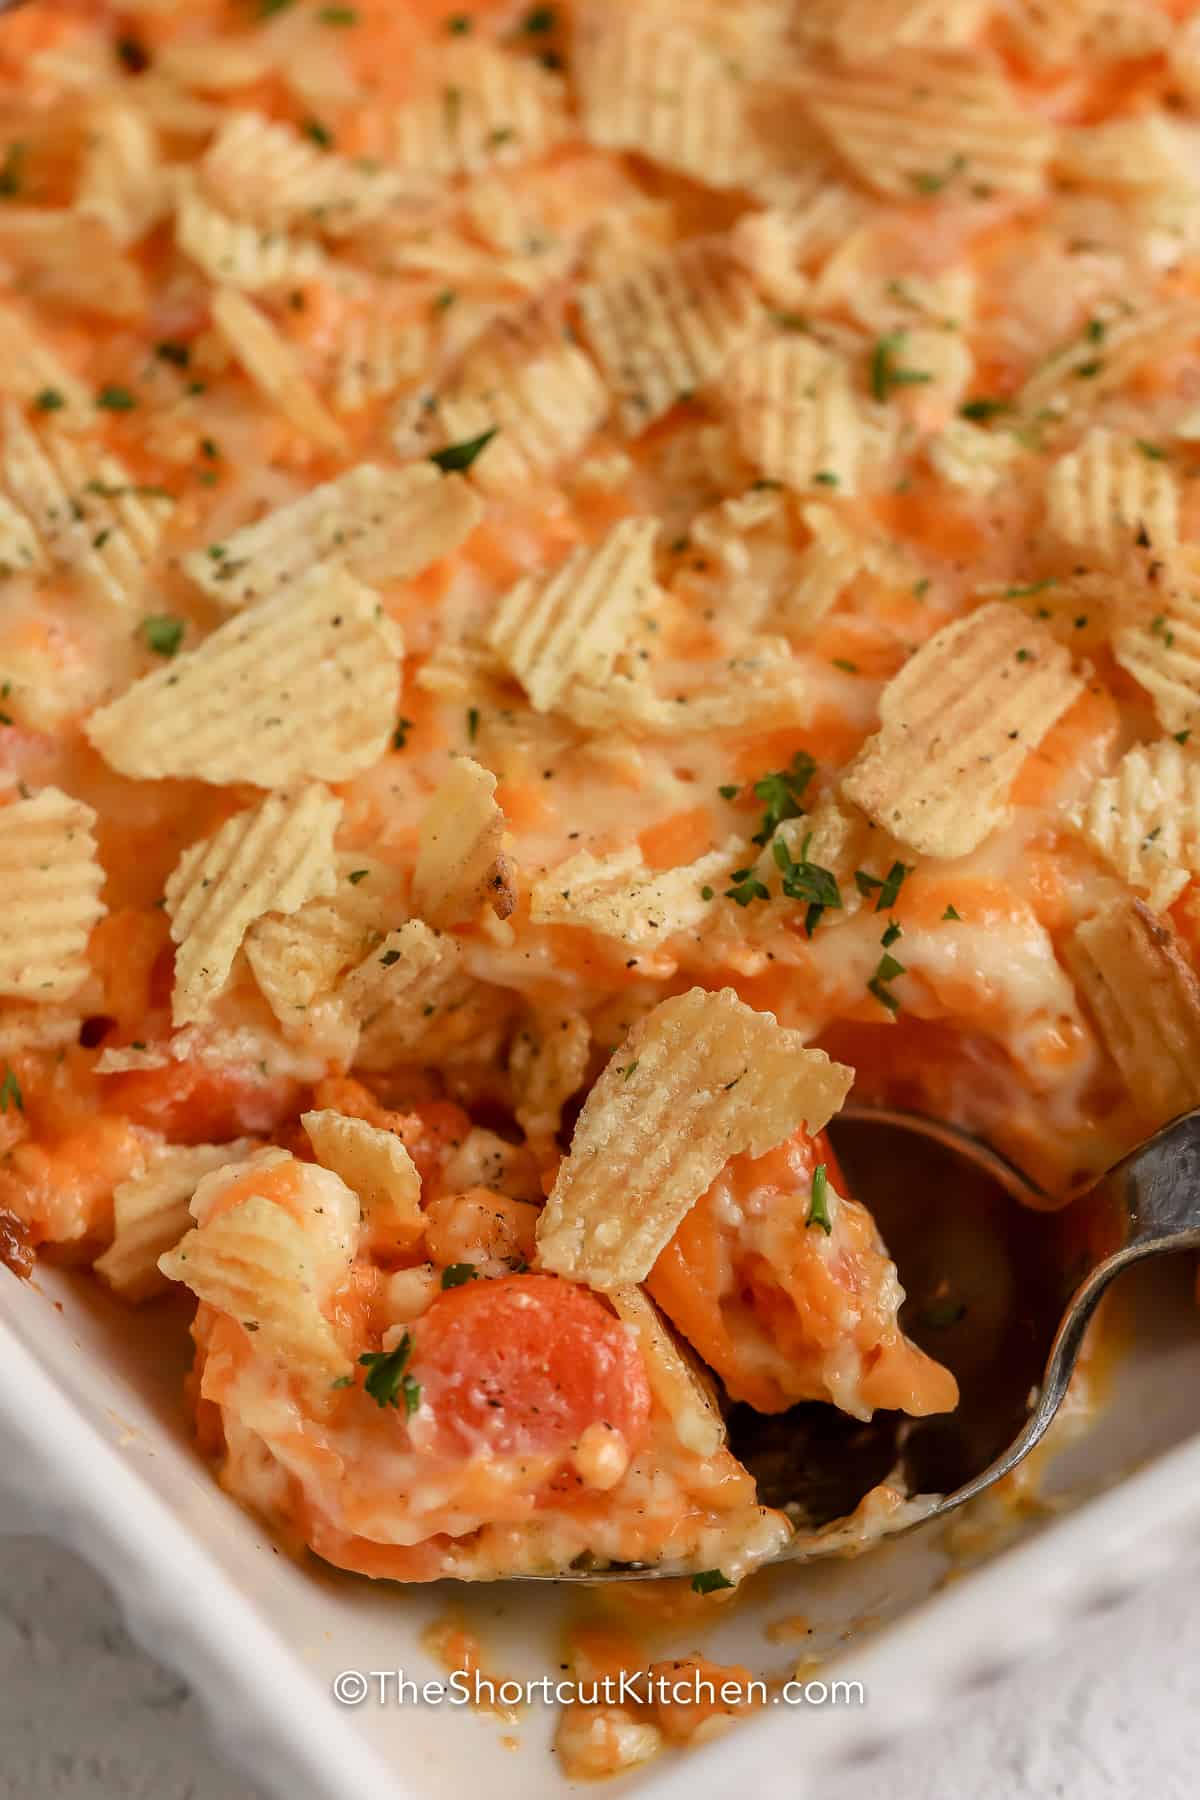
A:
184 463 482 607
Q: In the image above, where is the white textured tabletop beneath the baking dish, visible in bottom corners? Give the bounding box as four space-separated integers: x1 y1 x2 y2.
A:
0 1519 1200 1800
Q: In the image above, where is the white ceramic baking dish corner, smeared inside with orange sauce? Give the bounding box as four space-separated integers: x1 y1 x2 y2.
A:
0 1262 1200 1800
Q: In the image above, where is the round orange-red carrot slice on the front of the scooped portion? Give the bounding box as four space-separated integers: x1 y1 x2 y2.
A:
412 1274 649 1456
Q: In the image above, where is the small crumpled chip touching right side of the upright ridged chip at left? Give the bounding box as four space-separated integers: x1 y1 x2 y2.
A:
245 851 403 1048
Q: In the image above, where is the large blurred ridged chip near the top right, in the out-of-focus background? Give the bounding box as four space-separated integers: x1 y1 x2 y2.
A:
802 50 1054 200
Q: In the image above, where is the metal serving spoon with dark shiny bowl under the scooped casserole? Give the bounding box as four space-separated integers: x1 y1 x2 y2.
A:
546 1107 1200 1580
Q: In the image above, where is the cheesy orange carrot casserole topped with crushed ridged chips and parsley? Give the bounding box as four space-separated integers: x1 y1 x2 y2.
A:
0 0 1200 1586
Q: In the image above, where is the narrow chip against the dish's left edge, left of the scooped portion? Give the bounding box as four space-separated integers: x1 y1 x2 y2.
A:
92 1138 254 1305
